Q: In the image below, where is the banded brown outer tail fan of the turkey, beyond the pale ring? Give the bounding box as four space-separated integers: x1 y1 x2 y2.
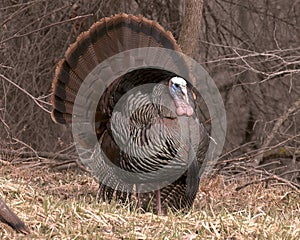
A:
51 14 180 124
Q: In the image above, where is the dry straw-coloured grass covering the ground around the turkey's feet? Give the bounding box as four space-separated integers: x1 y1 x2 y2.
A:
0 163 300 239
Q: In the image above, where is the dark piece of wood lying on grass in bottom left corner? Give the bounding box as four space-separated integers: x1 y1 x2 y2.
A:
0 198 29 234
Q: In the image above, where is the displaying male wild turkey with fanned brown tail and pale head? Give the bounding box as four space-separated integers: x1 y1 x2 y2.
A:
51 14 208 212
